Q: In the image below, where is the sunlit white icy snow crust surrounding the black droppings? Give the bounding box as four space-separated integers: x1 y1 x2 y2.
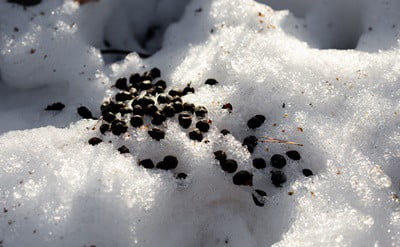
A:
0 0 400 247
